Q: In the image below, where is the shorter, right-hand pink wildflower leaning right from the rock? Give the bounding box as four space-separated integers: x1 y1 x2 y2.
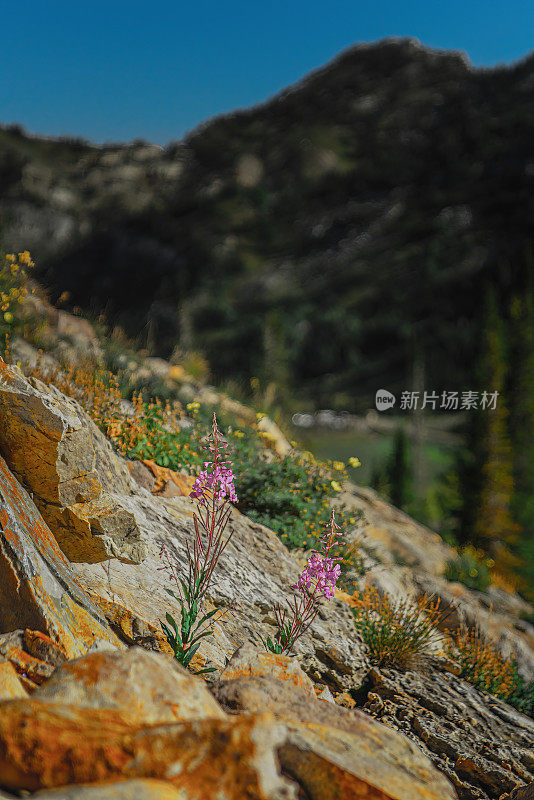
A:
266 511 348 654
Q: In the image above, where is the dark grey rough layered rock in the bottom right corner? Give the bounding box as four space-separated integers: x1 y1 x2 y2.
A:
360 670 534 800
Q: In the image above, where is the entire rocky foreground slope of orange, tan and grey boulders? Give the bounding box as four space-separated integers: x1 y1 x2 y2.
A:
0 315 534 800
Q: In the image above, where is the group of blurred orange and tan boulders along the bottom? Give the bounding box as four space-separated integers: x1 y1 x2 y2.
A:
0 648 455 800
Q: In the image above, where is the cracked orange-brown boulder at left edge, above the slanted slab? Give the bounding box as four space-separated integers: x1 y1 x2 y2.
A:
0 362 146 563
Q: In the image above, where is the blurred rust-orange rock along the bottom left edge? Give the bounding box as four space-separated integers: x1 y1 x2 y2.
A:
0 699 295 800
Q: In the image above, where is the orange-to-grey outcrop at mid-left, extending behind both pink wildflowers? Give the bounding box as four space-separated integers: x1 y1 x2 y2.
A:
0 365 368 691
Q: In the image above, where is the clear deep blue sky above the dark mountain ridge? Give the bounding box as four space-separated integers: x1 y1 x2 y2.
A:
0 0 534 144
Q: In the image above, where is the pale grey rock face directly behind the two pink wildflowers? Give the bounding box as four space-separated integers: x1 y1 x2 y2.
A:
72 489 369 691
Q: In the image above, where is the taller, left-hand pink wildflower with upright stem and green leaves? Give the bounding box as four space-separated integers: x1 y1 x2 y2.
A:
161 414 237 674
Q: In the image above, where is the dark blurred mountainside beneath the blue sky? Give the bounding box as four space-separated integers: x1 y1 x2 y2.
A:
0 40 534 410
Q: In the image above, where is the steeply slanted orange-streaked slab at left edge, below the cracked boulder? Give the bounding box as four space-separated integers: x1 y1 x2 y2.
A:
0 456 123 658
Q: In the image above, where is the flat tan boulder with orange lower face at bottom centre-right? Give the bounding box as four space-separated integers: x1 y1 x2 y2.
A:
213 677 455 800
